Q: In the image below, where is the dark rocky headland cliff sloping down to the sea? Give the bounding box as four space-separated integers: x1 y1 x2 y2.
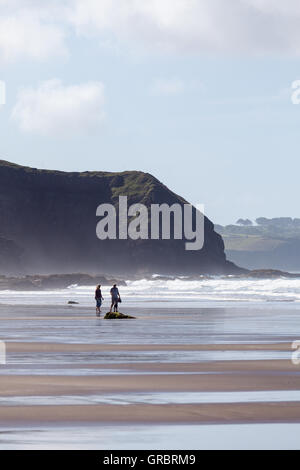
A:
0 161 240 275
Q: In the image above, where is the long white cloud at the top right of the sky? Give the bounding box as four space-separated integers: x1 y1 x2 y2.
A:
68 0 300 54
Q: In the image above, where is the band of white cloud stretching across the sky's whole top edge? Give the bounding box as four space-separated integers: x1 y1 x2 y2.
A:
0 0 300 60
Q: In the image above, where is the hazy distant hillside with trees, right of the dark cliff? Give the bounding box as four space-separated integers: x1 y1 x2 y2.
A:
215 217 300 271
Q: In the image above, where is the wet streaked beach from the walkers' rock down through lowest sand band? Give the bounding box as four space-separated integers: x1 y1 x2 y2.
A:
0 307 300 448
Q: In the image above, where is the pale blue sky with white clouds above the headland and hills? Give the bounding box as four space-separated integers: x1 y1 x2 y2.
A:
0 0 300 224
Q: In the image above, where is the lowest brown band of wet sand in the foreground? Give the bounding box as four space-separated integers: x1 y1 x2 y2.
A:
0 402 300 426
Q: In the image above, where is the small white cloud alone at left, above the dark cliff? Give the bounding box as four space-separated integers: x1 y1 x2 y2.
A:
11 79 105 136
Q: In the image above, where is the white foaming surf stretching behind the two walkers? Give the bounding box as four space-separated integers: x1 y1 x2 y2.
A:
0 276 300 306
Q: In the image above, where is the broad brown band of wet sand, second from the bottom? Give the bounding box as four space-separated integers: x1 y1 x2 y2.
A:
0 361 300 396
